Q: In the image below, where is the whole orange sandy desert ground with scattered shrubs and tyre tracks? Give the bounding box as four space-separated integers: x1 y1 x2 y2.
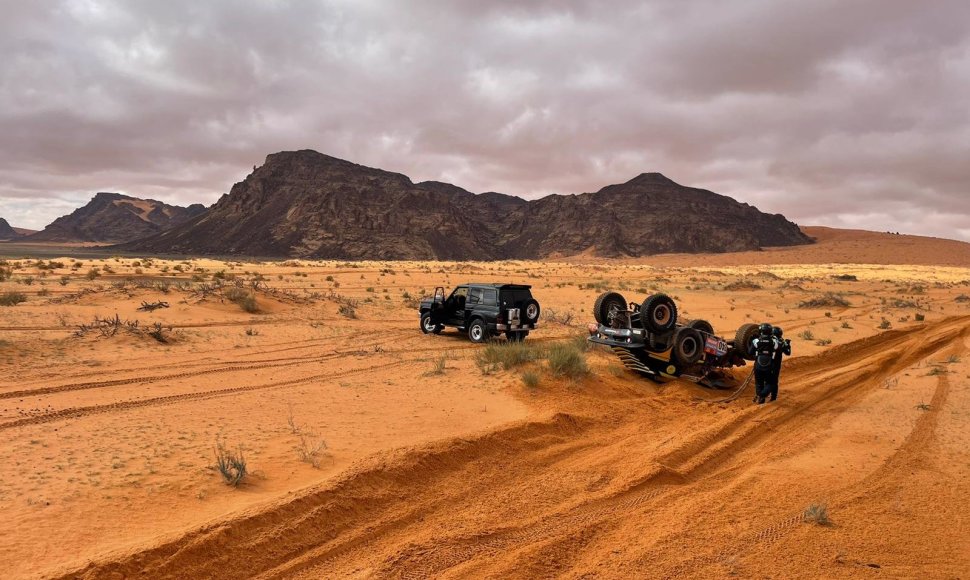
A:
0 229 970 578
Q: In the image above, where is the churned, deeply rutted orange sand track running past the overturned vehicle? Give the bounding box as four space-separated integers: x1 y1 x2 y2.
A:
60 316 970 578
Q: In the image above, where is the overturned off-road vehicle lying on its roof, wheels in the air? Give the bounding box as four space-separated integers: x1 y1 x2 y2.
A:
589 292 758 387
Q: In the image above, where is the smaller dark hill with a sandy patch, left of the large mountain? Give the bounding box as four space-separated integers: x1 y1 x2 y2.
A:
25 192 205 243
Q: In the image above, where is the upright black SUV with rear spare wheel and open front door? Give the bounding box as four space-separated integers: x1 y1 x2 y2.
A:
421 284 539 342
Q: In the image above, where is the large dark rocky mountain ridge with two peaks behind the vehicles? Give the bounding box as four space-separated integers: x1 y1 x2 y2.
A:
122 150 811 260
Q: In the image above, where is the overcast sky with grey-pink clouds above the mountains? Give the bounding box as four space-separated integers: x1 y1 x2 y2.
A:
0 0 970 240
